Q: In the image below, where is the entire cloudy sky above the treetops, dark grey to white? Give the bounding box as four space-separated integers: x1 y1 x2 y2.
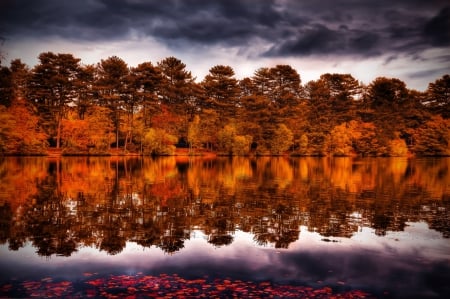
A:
0 0 450 91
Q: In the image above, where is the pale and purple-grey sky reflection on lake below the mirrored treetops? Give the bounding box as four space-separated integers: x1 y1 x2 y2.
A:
0 223 450 297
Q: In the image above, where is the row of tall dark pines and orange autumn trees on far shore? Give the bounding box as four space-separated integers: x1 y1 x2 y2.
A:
0 52 450 157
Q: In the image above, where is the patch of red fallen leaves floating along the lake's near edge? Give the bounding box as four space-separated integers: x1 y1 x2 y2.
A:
0 272 371 299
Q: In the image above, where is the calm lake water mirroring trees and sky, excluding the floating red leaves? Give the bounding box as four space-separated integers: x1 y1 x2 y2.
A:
0 157 450 298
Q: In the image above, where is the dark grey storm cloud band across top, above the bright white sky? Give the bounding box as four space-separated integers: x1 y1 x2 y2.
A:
0 0 450 57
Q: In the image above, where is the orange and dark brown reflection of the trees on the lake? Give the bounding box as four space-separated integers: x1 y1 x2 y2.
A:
0 158 450 256
